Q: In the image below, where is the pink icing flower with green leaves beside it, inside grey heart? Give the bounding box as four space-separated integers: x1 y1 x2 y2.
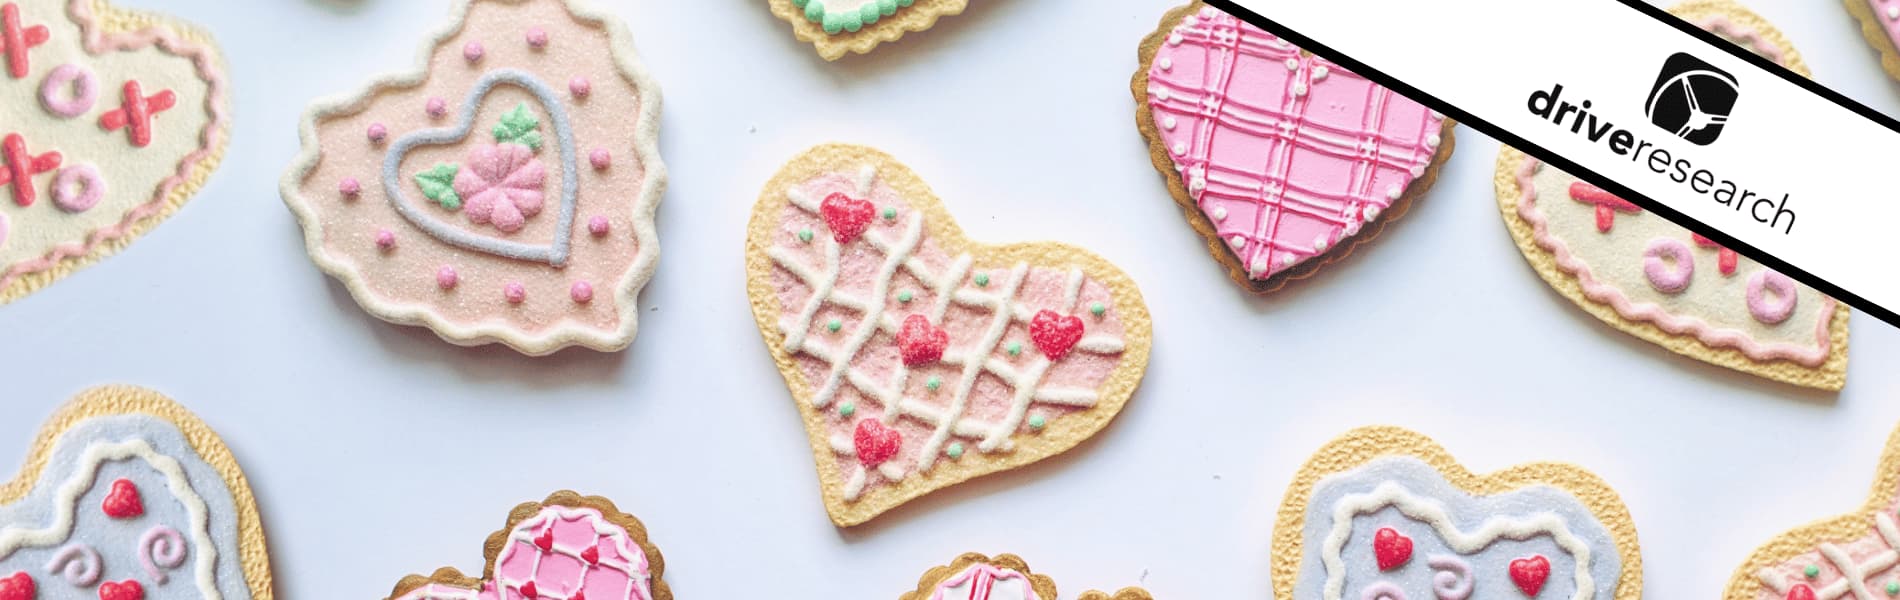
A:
456 144 547 234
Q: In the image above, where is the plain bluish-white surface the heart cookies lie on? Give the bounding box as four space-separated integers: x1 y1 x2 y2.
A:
0 0 1900 600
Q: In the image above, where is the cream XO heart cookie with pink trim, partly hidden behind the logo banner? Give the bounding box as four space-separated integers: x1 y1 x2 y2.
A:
1495 2 1849 389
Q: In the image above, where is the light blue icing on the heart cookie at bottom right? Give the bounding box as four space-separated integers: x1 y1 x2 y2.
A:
1292 456 1623 600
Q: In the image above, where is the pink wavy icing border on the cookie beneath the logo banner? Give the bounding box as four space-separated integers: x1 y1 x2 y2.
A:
1516 158 1837 366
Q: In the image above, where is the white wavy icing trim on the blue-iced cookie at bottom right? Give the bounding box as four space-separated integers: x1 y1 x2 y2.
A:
1321 480 1596 600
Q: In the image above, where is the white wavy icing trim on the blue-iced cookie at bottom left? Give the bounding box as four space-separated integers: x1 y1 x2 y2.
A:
0 439 224 600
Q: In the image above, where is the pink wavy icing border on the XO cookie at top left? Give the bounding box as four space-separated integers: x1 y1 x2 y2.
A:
0 0 228 289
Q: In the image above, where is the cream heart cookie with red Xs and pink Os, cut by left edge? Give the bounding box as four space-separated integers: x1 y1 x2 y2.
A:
0 0 230 304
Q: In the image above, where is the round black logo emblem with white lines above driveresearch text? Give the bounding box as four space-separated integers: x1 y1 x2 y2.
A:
1644 51 1740 146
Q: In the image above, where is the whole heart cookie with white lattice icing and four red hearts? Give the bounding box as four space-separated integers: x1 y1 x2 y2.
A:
745 144 1150 526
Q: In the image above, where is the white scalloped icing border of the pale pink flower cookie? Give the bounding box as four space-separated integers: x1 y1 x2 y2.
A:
277 0 667 357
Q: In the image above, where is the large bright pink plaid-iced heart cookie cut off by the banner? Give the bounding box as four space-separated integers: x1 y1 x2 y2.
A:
1132 2 1452 292
